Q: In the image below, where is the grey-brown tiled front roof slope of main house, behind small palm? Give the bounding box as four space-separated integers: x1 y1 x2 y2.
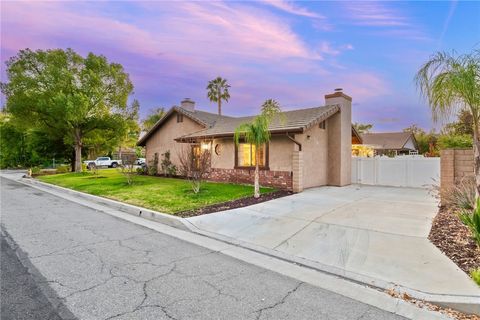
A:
176 105 340 141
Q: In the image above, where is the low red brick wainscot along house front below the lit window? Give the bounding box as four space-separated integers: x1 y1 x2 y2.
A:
209 168 292 190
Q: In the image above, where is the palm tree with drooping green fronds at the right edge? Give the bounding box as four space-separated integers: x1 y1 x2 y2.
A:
415 50 480 192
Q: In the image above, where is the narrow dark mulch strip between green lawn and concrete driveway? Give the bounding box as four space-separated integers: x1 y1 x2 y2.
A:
175 190 292 218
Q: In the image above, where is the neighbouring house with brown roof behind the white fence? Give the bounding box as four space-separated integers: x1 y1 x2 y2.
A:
354 132 418 155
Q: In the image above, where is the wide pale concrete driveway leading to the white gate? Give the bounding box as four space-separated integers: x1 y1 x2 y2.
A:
188 185 480 297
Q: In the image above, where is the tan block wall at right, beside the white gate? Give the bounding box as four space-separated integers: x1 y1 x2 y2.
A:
440 149 474 189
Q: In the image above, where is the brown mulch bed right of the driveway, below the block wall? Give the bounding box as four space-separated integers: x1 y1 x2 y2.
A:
428 208 480 274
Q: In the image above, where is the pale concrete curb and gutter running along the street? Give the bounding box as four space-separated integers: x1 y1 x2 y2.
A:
1 175 472 320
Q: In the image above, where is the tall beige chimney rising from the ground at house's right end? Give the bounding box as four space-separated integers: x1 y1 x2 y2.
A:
325 88 352 186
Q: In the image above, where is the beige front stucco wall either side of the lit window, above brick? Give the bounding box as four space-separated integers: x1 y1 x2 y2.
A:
212 135 294 171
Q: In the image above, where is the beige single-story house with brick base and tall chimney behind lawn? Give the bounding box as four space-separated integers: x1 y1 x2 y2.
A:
138 92 354 192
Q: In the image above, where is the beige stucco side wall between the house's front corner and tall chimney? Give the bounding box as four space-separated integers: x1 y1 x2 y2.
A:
295 121 329 188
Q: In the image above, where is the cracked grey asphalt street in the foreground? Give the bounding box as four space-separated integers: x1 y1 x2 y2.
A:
1 179 404 320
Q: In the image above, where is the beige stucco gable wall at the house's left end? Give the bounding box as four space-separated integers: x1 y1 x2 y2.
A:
145 112 203 172
